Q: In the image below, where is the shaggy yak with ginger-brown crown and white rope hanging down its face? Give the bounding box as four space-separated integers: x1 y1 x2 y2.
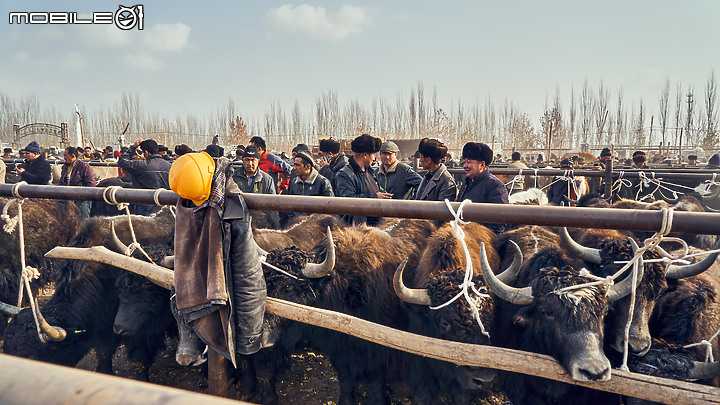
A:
403 223 500 404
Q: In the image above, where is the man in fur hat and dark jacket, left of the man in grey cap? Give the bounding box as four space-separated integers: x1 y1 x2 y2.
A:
335 134 392 225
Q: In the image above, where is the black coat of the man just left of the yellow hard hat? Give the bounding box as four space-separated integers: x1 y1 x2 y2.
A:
118 146 172 190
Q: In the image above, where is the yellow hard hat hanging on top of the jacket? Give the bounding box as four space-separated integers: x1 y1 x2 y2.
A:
170 152 215 206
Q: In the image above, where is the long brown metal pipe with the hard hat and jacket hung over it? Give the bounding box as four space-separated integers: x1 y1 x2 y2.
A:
0 184 720 234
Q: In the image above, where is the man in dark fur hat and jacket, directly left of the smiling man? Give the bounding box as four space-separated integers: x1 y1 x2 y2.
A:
415 138 457 201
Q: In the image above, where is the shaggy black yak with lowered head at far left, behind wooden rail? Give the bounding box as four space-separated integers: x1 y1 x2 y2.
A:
3 209 174 379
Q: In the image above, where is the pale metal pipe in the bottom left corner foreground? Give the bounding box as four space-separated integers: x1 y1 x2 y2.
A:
0 354 247 405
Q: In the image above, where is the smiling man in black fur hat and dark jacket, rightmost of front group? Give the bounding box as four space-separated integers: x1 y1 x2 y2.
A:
457 142 509 233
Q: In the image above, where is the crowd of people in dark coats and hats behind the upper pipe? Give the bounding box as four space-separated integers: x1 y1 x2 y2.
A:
0 134 720 227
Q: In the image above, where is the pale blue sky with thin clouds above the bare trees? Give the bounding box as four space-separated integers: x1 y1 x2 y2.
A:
0 0 720 132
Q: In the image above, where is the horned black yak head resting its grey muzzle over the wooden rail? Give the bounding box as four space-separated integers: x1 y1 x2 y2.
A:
481 245 632 381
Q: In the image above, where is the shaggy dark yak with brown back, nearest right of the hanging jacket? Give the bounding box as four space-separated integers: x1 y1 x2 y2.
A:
263 220 432 404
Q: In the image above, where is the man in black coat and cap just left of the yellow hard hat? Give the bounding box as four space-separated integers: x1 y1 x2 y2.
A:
118 139 171 215
